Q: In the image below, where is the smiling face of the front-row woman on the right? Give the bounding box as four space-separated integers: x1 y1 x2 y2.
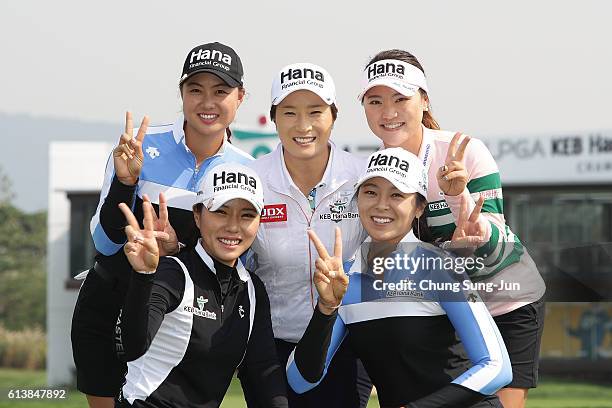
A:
357 177 424 244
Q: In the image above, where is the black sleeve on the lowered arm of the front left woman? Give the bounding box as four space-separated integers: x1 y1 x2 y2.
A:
240 274 288 408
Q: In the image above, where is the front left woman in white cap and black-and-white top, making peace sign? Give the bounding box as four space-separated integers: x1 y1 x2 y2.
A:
117 163 287 407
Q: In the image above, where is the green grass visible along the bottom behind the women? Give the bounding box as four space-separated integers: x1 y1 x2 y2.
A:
0 368 612 408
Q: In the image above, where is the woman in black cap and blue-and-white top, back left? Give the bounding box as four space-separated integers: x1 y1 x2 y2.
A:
72 42 252 408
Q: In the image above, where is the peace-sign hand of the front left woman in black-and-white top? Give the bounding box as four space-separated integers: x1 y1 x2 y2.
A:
119 201 168 273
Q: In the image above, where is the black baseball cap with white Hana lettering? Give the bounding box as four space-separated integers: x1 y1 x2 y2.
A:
179 42 244 87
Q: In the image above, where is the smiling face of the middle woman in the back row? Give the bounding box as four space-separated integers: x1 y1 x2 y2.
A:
274 89 334 160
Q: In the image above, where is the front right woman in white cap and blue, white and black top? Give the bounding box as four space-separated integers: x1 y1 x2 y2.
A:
287 148 512 408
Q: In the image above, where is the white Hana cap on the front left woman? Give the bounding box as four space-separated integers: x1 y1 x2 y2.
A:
194 163 264 213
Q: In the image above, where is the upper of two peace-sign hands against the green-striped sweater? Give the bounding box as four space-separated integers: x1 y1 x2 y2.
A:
436 132 470 196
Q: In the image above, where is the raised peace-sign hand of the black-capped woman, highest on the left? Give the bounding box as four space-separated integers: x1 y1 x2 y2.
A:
113 112 149 186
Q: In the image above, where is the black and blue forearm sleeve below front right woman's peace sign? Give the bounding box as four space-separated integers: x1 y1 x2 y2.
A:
287 307 347 394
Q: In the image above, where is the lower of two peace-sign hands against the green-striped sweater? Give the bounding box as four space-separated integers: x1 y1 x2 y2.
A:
449 195 487 256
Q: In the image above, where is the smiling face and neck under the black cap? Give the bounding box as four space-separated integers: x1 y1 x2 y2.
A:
181 72 244 143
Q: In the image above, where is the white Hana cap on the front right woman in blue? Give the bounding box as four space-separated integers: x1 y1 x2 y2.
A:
355 147 427 198
